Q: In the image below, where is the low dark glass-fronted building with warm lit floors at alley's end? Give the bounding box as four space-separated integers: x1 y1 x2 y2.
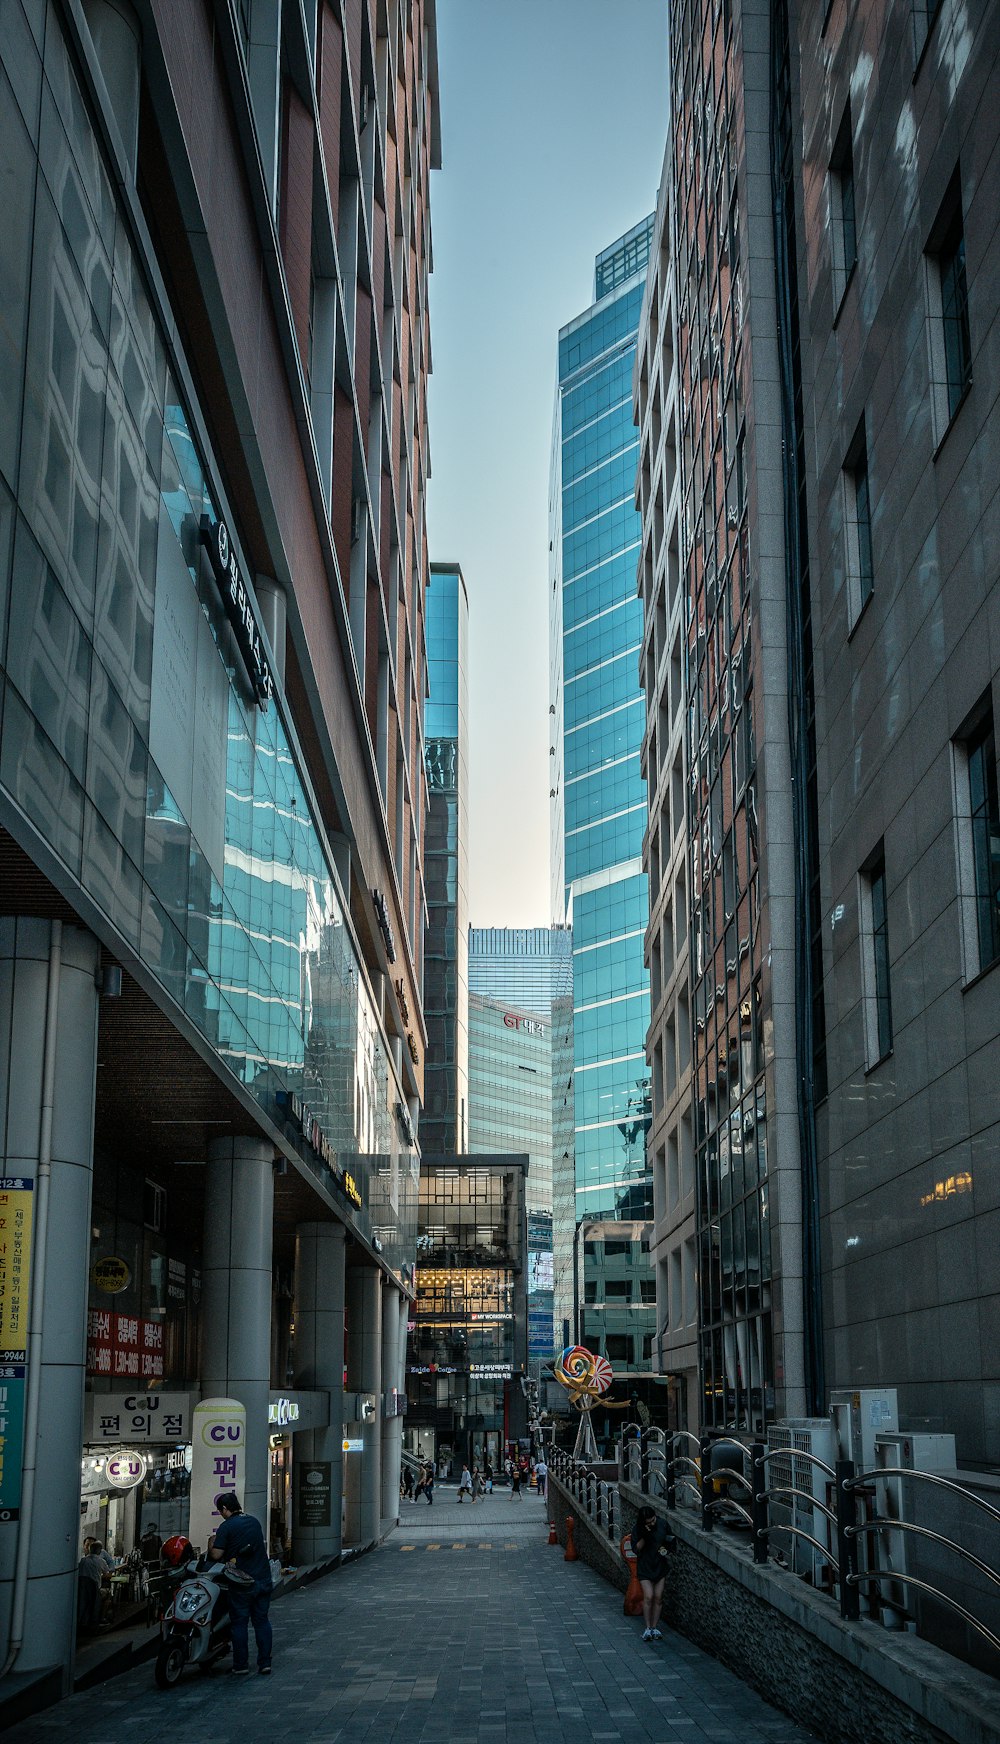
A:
405 1156 527 1470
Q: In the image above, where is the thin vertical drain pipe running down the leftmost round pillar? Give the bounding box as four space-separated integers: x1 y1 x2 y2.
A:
0 921 63 1678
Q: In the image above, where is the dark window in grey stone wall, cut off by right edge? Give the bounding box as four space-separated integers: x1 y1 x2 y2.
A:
955 699 1000 980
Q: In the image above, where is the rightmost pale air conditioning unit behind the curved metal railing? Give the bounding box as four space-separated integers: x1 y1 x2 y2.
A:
869 1430 956 1629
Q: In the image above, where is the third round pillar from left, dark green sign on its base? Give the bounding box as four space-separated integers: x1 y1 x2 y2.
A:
291 1223 346 1563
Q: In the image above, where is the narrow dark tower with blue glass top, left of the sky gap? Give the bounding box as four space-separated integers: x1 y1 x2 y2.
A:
421 563 469 1153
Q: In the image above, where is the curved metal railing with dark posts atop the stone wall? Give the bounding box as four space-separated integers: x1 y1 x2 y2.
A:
610 1423 1000 1657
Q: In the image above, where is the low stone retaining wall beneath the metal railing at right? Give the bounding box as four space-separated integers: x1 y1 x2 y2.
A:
548 1470 1000 1744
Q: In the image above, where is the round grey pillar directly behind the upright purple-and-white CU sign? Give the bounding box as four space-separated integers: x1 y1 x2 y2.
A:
201 1139 274 1538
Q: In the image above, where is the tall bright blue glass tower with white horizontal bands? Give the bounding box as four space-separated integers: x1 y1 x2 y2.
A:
550 218 654 1369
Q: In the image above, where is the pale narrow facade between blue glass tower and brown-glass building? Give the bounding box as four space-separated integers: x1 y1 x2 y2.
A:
631 143 702 1428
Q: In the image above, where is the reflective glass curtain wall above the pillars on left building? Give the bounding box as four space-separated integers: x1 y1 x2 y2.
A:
0 7 415 1271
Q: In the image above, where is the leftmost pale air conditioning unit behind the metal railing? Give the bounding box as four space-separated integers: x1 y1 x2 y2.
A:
766 1418 836 1591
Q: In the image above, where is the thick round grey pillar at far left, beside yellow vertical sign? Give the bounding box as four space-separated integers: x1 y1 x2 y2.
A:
0 919 99 1686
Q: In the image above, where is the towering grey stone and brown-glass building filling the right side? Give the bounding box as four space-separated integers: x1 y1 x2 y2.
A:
656 0 1000 1463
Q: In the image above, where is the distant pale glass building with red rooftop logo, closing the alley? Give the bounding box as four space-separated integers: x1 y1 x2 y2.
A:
469 926 572 1366
